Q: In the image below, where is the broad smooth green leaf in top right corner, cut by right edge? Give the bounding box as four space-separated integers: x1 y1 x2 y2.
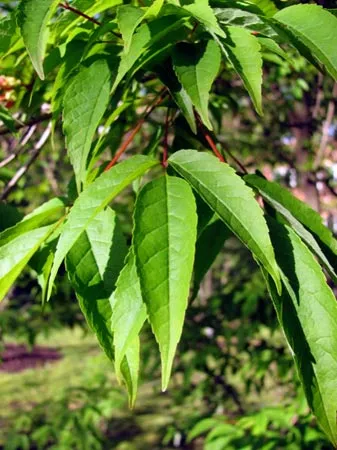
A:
273 5 337 80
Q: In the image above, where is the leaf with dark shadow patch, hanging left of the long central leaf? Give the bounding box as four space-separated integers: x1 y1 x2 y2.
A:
66 208 127 360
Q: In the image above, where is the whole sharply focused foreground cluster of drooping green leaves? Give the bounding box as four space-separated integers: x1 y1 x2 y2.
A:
0 0 337 446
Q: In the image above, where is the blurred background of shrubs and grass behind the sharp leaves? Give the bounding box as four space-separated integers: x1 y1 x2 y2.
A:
0 1 337 450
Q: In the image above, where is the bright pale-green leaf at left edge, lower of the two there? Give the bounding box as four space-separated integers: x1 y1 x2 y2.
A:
0 225 55 301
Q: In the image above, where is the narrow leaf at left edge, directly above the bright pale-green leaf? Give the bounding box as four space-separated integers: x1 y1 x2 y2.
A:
0 198 65 247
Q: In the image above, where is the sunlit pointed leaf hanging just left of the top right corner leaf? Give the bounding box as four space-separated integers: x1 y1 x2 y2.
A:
222 26 263 115
